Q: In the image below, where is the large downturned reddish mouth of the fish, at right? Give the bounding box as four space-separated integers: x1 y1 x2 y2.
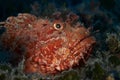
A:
70 35 96 63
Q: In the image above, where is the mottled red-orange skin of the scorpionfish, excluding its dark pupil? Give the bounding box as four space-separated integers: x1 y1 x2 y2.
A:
1 13 95 75
